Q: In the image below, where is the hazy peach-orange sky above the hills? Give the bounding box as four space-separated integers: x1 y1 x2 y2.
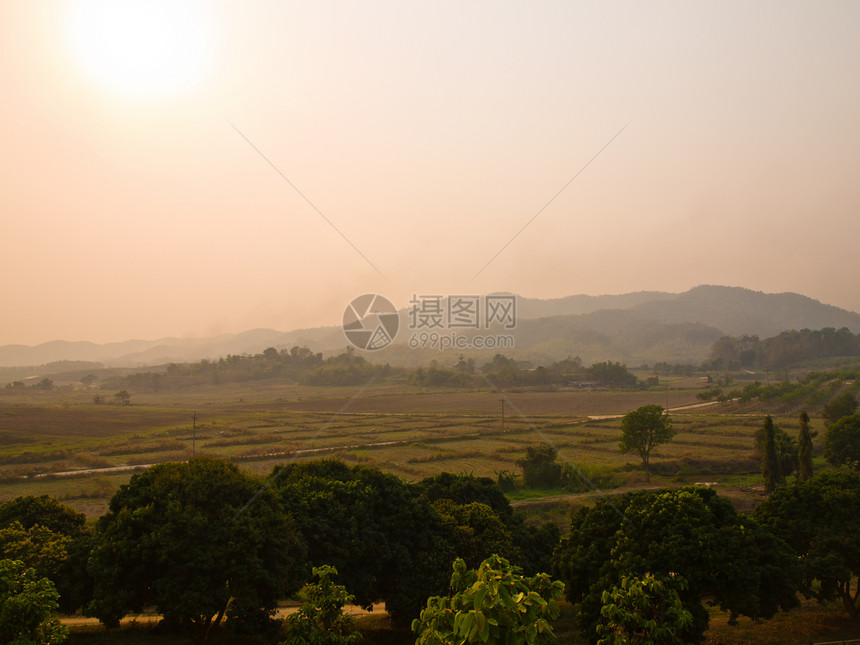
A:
0 0 860 345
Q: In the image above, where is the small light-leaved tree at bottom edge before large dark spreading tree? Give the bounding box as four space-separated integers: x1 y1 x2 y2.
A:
596 573 693 645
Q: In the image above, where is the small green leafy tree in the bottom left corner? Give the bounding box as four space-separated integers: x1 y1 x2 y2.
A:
0 560 69 645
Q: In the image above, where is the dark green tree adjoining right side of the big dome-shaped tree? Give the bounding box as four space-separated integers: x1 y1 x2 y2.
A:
272 460 456 624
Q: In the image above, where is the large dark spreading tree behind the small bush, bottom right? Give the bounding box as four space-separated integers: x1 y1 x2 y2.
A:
553 486 799 642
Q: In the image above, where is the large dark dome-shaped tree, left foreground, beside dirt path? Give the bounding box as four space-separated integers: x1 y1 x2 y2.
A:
88 457 304 641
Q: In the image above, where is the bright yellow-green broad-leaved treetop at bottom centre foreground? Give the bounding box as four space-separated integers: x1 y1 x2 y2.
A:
412 555 564 645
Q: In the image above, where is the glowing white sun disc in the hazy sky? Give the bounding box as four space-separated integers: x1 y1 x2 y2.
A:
67 0 213 99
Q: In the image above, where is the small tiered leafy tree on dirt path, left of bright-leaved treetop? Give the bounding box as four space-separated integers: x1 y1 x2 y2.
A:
281 565 361 645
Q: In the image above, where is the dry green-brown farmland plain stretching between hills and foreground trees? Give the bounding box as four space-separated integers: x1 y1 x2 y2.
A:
0 379 824 523
